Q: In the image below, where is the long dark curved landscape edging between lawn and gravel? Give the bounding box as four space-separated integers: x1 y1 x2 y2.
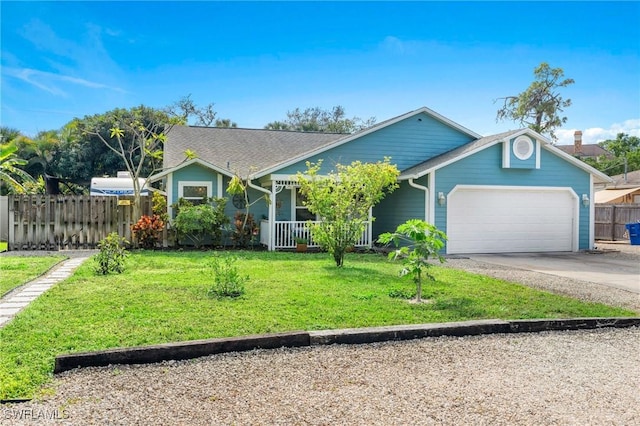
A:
53 317 640 374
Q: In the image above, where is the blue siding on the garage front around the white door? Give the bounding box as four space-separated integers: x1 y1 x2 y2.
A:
435 144 590 250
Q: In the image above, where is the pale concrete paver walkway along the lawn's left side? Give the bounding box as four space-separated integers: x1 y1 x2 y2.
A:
0 256 90 328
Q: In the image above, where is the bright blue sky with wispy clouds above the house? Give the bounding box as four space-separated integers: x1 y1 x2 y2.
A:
0 1 640 143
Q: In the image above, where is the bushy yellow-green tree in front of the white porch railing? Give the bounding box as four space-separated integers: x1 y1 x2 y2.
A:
297 158 400 267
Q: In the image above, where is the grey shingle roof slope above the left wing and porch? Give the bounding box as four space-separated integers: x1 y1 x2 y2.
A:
164 126 348 176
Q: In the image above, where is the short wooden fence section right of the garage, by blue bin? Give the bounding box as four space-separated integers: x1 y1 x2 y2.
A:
595 204 640 241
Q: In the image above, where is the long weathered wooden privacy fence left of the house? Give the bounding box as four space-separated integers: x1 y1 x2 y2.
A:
8 195 151 250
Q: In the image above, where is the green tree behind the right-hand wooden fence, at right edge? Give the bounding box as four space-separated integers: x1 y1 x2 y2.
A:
584 133 640 176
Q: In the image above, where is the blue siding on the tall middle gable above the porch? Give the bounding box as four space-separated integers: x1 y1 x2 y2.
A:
275 114 473 175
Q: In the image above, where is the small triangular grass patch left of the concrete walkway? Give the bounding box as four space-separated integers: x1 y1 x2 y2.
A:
0 256 64 296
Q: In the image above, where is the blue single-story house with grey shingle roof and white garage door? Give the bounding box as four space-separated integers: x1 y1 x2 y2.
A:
151 108 610 254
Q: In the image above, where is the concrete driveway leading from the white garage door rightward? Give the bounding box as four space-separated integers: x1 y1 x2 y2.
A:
468 251 640 294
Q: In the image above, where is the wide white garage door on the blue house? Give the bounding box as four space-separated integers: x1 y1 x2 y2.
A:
447 187 577 254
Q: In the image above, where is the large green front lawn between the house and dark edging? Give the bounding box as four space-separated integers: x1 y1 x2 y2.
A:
0 252 635 399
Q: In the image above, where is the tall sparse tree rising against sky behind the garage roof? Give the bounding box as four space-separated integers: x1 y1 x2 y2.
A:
494 62 574 141
